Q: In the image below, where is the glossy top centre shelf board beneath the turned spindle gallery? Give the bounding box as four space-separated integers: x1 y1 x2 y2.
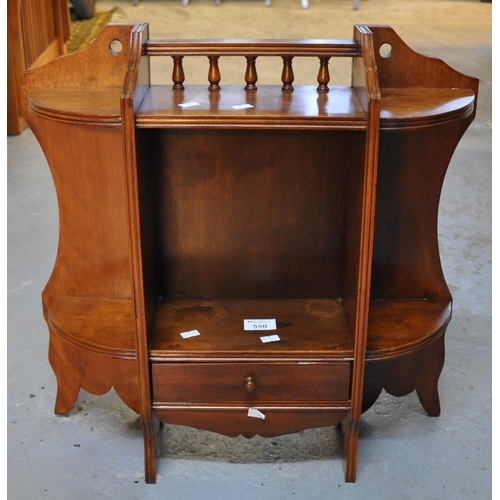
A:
136 85 367 130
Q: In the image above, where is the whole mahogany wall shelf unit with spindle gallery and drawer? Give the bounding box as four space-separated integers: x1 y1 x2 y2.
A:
22 24 478 482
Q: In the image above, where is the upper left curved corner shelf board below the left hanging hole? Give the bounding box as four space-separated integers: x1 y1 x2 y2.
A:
28 88 121 126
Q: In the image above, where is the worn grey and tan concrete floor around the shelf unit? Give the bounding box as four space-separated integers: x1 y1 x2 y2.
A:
7 0 492 500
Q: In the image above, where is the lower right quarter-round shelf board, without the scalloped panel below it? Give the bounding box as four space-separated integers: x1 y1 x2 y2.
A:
366 300 452 361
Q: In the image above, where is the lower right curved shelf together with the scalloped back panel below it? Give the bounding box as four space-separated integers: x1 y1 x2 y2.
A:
363 300 451 416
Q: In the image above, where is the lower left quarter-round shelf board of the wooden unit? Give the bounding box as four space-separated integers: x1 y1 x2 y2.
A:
46 296 136 359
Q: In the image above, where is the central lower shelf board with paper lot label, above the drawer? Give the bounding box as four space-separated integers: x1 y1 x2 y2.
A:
150 299 353 362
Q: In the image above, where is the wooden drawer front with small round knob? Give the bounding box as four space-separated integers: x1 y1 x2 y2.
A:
153 362 351 404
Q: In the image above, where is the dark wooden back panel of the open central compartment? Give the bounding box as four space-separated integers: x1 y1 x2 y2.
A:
139 130 349 299
